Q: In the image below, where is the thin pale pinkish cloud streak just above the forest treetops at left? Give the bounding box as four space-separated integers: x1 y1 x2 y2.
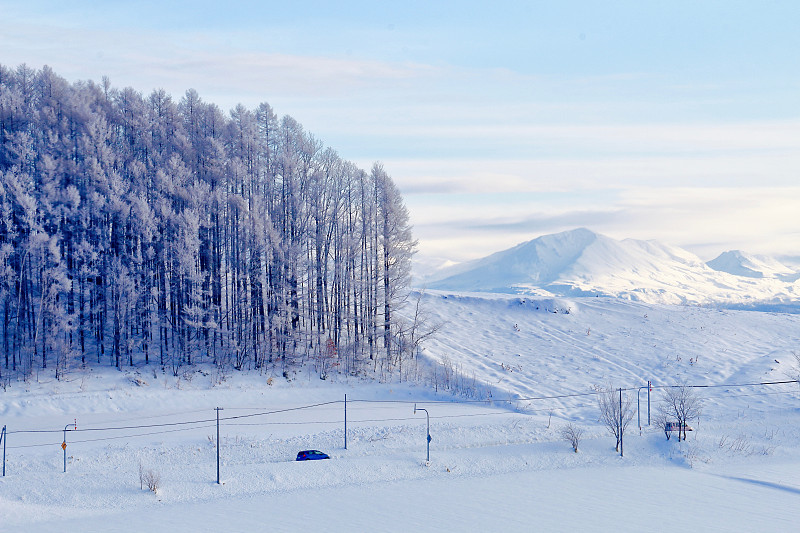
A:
0 20 438 105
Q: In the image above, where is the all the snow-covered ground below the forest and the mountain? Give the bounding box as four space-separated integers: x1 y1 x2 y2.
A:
0 292 800 532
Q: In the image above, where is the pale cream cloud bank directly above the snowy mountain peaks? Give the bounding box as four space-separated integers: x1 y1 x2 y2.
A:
410 187 800 261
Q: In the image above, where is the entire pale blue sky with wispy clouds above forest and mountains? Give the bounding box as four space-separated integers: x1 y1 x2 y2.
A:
0 0 800 261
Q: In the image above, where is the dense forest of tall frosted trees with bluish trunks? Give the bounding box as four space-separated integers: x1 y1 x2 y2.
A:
0 65 415 380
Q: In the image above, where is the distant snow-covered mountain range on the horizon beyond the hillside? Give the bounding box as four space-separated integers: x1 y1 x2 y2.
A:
426 228 800 305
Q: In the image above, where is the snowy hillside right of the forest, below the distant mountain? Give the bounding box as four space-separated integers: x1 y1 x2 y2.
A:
412 291 800 407
